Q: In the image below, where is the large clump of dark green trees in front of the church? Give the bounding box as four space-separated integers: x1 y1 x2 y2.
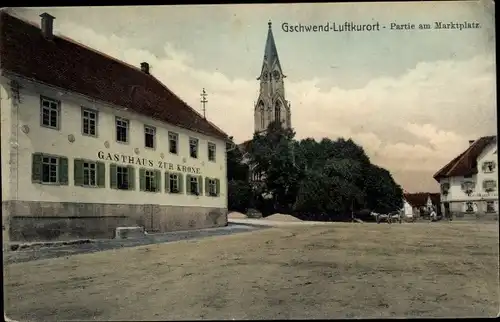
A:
244 123 403 220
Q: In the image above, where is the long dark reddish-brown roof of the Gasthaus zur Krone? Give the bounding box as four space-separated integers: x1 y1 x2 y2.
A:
0 11 228 139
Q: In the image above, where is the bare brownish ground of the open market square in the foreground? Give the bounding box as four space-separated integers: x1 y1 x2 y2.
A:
4 223 499 321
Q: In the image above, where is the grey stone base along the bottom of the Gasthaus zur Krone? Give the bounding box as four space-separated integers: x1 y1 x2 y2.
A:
2 201 227 241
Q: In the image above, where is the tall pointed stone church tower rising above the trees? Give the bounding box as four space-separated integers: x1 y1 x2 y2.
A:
254 21 292 132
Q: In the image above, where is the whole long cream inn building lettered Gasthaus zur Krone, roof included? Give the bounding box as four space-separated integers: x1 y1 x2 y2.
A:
0 12 228 241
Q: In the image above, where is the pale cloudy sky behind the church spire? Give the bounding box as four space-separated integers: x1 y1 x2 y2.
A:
7 1 497 192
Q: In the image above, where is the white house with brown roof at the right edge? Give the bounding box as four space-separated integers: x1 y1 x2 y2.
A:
434 136 498 220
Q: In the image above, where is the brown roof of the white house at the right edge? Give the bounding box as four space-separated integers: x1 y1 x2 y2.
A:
434 135 497 181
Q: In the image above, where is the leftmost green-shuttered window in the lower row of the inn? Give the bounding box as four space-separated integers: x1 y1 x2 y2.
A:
31 153 68 185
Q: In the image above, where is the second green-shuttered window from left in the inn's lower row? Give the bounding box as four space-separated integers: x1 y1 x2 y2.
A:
74 159 106 188
